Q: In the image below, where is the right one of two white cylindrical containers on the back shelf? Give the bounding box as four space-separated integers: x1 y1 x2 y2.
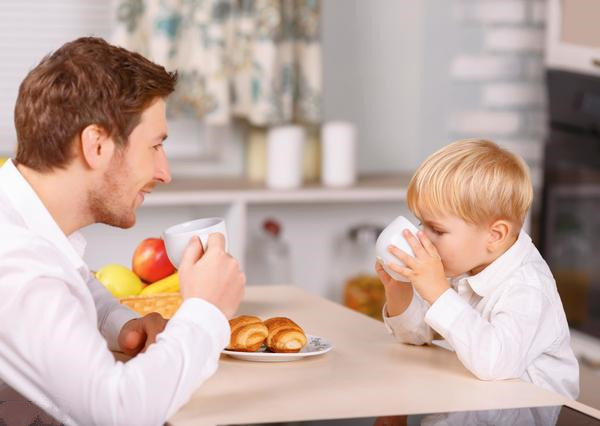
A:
321 121 356 187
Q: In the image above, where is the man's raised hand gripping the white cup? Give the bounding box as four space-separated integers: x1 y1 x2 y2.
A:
179 233 246 318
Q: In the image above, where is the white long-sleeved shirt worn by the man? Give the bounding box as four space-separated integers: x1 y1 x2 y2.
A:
0 160 230 425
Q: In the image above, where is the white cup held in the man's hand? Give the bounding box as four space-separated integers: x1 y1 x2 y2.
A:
162 217 227 268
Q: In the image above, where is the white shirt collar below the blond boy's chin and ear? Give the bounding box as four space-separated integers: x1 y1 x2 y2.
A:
466 231 532 297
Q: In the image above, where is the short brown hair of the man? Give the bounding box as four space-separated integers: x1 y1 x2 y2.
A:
15 37 177 172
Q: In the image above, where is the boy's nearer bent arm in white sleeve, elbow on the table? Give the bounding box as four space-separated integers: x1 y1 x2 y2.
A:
425 285 551 380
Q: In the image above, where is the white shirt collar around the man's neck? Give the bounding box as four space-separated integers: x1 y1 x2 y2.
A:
0 159 87 276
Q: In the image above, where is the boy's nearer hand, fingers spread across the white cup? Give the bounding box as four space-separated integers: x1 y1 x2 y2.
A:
388 229 450 304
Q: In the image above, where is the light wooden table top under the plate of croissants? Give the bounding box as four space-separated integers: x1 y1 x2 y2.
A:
169 286 600 426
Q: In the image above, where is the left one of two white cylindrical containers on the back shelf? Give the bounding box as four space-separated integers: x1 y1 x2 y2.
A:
266 125 305 189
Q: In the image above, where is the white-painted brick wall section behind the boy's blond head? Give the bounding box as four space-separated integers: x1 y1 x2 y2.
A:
447 0 547 186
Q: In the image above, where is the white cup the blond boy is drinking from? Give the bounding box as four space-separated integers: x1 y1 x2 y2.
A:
375 216 419 282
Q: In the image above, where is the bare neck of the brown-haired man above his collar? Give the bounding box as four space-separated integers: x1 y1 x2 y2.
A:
17 164 93 236
